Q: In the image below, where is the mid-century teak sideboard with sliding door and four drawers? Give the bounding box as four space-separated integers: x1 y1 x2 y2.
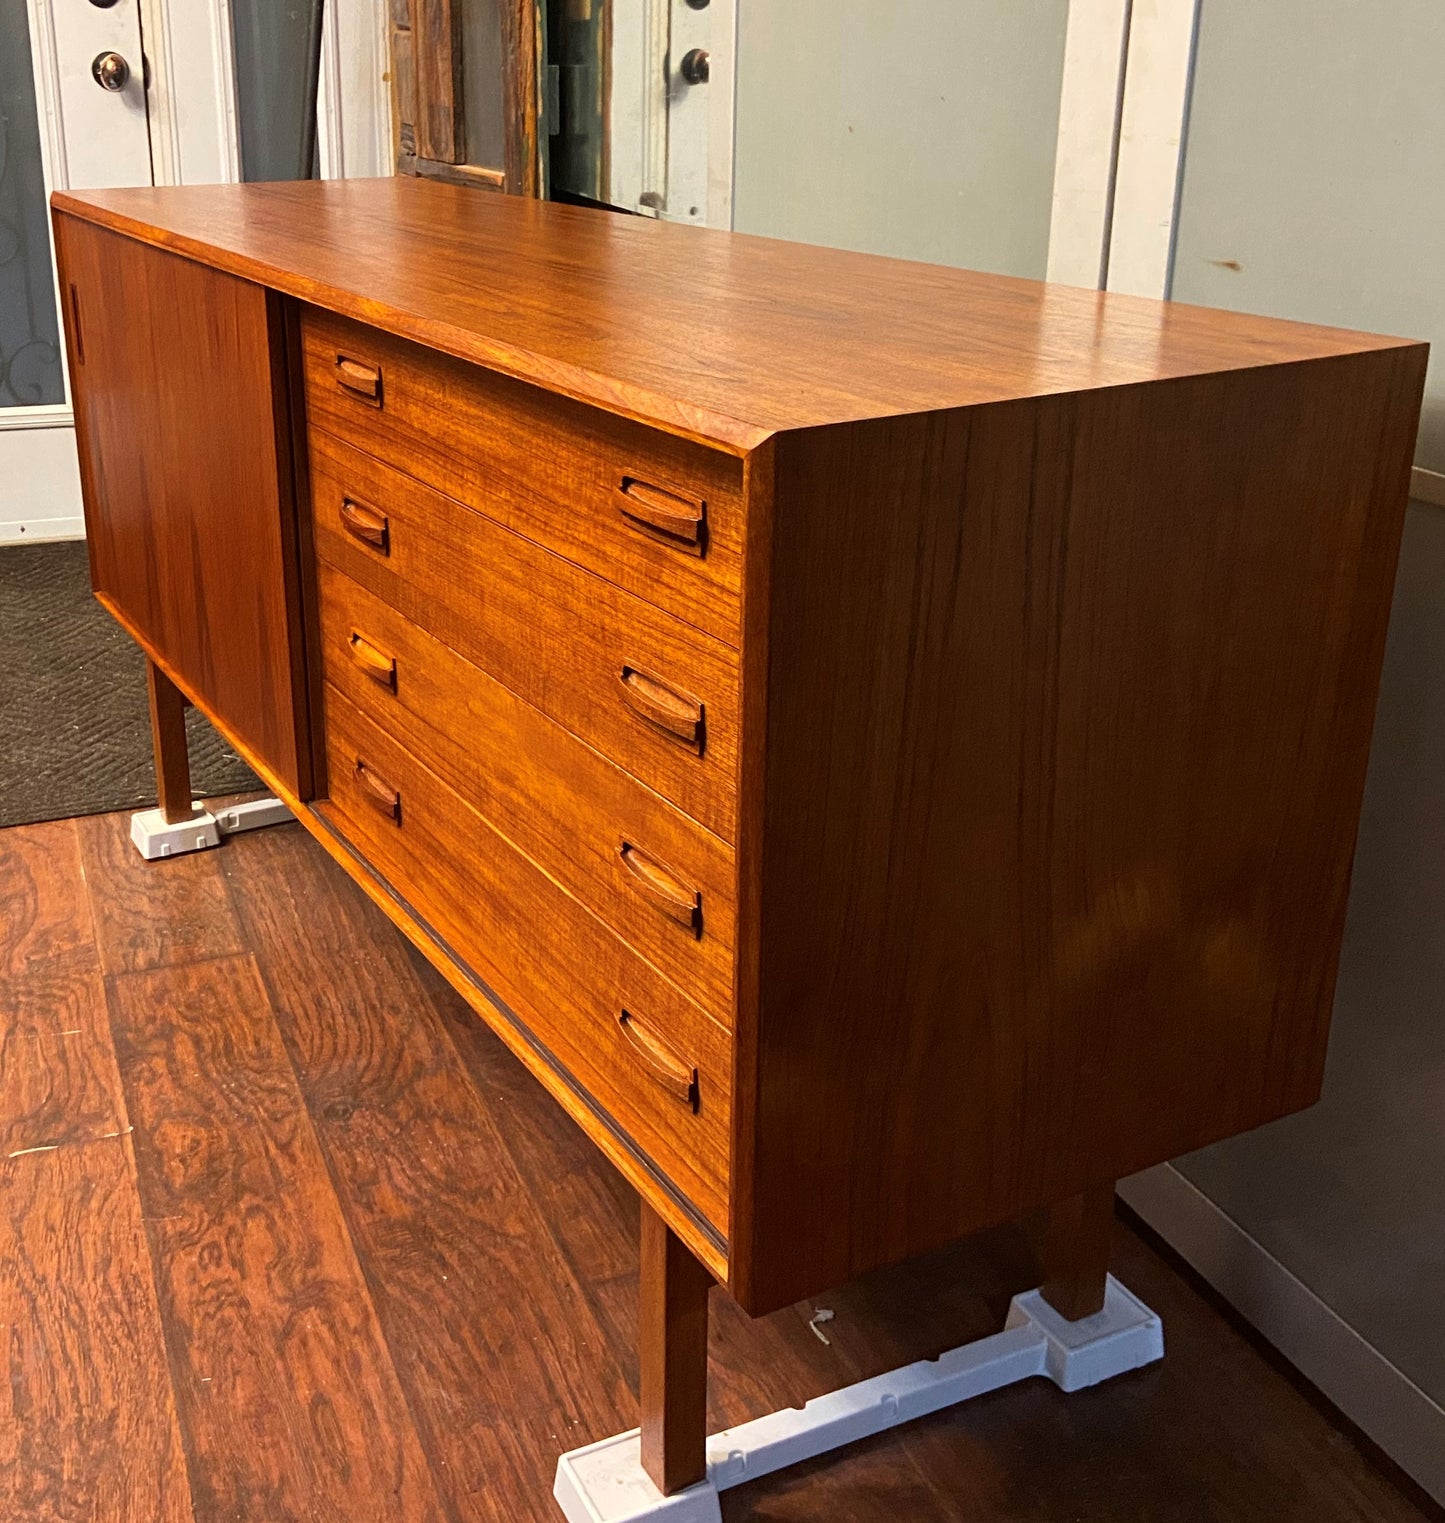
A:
53 180 1425 1491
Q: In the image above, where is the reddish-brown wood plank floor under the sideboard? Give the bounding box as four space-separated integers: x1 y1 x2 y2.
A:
0 816 1434 1523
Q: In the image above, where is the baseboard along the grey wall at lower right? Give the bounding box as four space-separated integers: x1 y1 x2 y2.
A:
1119 1164 1445 1503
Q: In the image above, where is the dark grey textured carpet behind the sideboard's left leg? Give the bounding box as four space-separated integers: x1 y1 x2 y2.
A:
0 542 260 825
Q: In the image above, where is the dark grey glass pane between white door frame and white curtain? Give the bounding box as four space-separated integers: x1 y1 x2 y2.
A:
231 0 321 180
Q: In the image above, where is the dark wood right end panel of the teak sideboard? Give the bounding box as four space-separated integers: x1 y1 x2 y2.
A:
732 349 1424 1311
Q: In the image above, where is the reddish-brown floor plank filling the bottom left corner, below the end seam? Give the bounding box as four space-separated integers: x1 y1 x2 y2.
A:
0 1138 192 1523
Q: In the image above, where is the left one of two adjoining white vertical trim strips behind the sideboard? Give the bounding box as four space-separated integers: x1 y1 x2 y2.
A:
1046 0 1130 289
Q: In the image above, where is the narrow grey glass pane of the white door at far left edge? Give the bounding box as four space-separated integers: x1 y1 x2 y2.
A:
0 0 65 407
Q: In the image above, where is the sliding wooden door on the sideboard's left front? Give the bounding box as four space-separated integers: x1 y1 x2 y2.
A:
56 218 309 793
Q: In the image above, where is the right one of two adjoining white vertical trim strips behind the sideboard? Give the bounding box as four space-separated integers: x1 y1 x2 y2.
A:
1105 0 1200 297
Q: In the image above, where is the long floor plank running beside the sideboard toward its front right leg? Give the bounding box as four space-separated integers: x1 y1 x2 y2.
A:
228 830 635 1523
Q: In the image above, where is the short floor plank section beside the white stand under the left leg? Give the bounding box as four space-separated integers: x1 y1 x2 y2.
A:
75 815 244 973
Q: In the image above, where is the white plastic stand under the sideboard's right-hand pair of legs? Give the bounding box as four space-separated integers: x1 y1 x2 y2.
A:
553 1275 1163 1523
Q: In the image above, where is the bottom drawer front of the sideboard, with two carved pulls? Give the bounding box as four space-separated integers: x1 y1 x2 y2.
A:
317 690 731 1237
